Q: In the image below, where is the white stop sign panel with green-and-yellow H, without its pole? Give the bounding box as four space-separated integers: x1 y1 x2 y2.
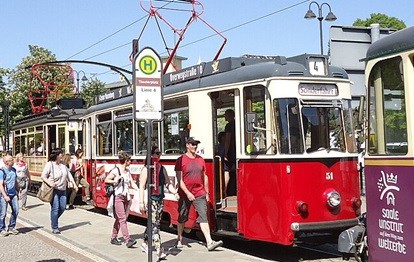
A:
133 47 163 121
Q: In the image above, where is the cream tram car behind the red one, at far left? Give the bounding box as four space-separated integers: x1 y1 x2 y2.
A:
11 98 85 192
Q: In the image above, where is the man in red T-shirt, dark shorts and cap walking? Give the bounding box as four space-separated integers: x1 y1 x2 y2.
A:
175 137 223 251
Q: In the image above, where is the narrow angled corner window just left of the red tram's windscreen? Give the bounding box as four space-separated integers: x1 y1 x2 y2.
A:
274 98 308 154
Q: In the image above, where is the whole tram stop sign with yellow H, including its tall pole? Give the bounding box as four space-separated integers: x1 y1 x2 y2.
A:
133 47 164 262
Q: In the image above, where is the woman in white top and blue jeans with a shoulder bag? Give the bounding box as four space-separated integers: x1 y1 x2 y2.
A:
41 149 75 234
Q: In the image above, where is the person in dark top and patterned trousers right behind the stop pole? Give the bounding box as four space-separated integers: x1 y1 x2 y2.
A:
139 146 179 260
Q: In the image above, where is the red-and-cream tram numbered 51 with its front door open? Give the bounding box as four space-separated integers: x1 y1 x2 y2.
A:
82 54 361 245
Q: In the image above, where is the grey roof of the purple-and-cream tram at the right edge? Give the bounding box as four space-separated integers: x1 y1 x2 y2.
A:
361 26 414 61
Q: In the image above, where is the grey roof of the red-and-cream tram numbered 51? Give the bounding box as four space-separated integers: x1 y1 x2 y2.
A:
85 54 348 114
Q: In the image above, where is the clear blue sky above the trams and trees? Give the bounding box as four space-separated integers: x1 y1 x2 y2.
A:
0 0 414 83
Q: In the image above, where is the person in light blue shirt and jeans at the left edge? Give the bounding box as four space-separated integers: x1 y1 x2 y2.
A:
0 155 21 237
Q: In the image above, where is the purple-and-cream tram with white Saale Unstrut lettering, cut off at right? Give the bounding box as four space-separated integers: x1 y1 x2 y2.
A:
365 27 414 262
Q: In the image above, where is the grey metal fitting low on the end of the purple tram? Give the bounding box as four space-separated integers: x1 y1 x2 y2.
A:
338 213 368 262
